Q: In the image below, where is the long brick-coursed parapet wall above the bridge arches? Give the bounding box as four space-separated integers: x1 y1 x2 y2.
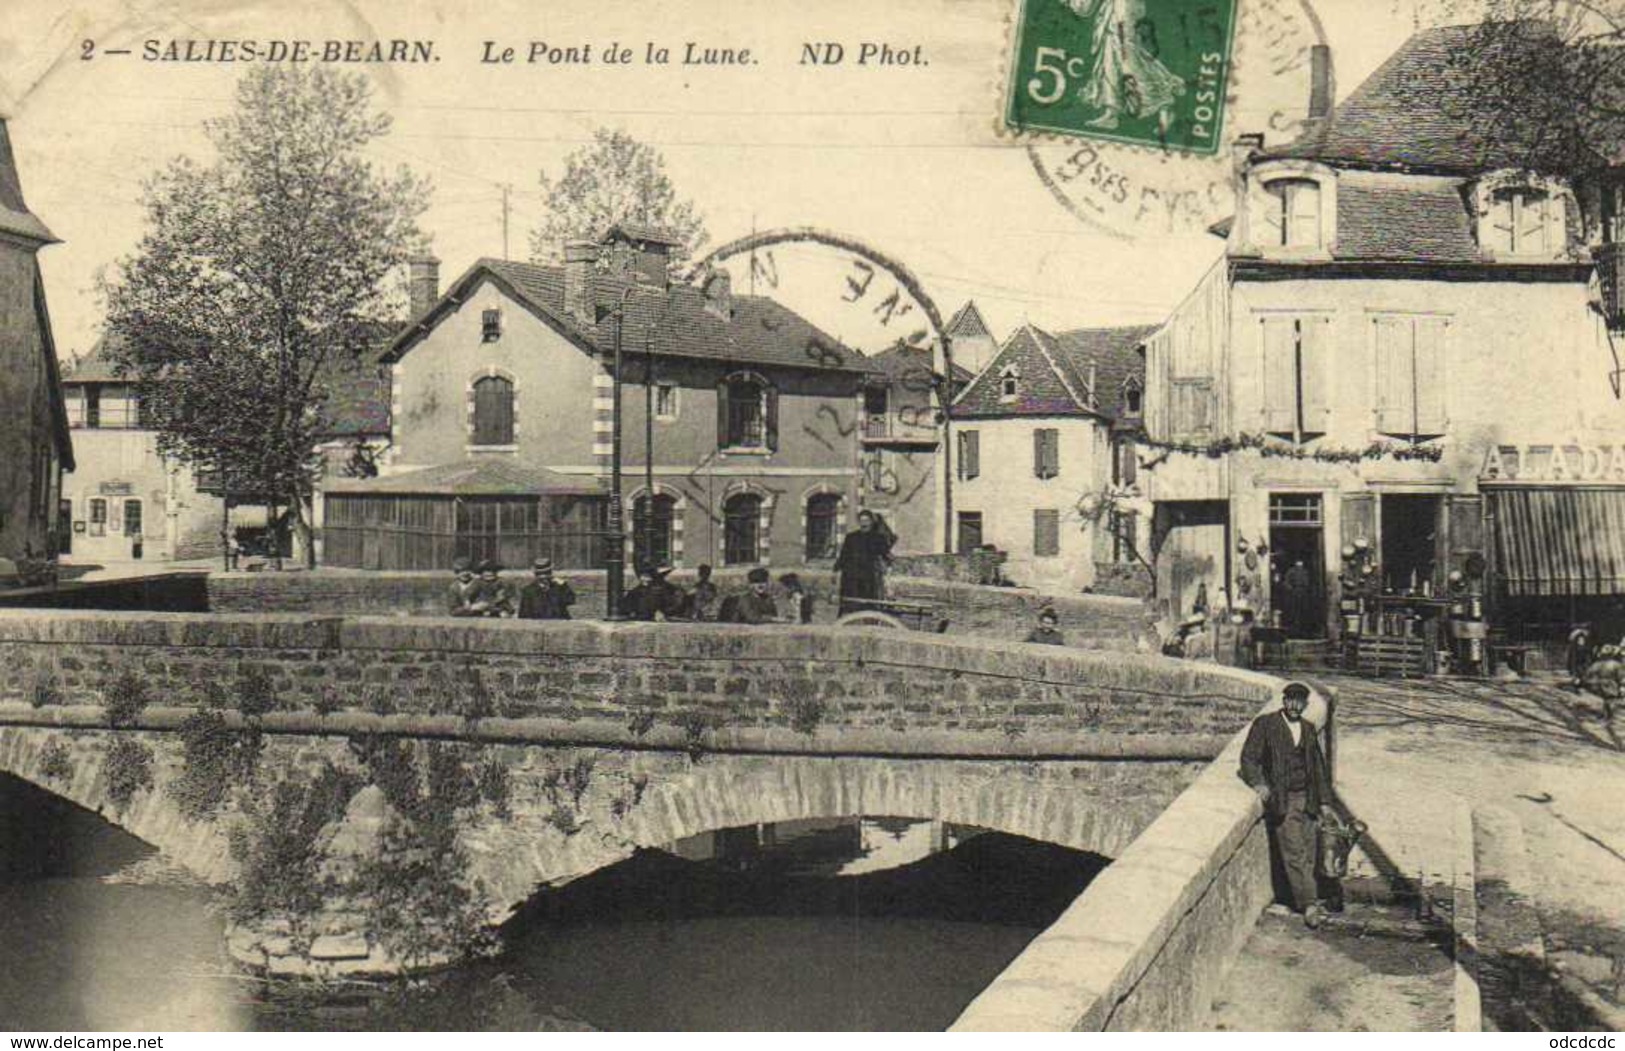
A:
0 611 1271 759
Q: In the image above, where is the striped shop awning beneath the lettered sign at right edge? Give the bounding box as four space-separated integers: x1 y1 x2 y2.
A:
1492 487 1625 595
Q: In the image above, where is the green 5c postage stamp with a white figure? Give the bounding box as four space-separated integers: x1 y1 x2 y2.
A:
1004 0 1238 153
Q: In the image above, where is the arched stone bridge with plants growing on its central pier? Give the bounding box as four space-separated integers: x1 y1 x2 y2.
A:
0 611 1293 1026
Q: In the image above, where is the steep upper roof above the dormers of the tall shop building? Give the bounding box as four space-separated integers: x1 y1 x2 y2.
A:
1264 21 1570 174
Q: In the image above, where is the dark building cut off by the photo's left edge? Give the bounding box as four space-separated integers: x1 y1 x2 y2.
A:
0 119 73 562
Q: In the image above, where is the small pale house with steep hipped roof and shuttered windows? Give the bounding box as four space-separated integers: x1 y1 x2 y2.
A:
952 325 1154 593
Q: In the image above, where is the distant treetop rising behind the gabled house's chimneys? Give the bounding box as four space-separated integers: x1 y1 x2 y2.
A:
530 128 710 262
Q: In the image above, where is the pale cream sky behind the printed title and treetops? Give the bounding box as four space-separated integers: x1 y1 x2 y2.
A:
0 0 1461 356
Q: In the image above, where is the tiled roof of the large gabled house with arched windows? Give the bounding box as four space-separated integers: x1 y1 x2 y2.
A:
385 258 876 372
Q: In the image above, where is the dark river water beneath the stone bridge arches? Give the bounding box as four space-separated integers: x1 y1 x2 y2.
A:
0 776 1103 1032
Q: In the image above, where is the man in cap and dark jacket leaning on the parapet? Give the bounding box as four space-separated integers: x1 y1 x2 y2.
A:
1242 682 1333 928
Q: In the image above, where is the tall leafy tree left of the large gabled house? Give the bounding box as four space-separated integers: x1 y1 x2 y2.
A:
107 65 427 564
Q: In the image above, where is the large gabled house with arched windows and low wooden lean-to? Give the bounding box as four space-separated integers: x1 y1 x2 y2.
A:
325 224 876 569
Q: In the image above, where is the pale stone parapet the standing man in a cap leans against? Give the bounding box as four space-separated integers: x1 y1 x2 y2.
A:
952 685 1272 1032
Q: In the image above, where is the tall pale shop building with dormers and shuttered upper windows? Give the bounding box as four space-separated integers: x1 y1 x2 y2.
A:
1141 26 1625 664
